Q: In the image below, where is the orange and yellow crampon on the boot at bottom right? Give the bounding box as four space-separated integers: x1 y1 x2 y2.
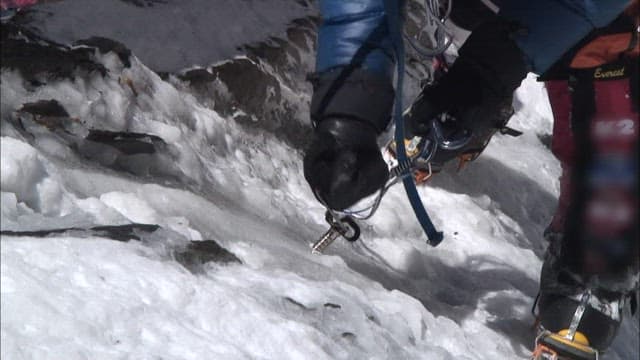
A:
531 330 599 360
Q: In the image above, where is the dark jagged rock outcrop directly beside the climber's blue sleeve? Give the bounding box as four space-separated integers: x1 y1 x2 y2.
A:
178 15 319 149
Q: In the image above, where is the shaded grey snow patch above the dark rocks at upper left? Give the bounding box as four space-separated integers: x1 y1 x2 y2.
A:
9 0 317 71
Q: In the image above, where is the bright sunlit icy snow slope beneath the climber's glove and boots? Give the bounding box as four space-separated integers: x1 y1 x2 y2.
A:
0 2 638 359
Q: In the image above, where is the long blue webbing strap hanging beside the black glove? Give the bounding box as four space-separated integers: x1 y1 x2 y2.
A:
384 0 443 246
